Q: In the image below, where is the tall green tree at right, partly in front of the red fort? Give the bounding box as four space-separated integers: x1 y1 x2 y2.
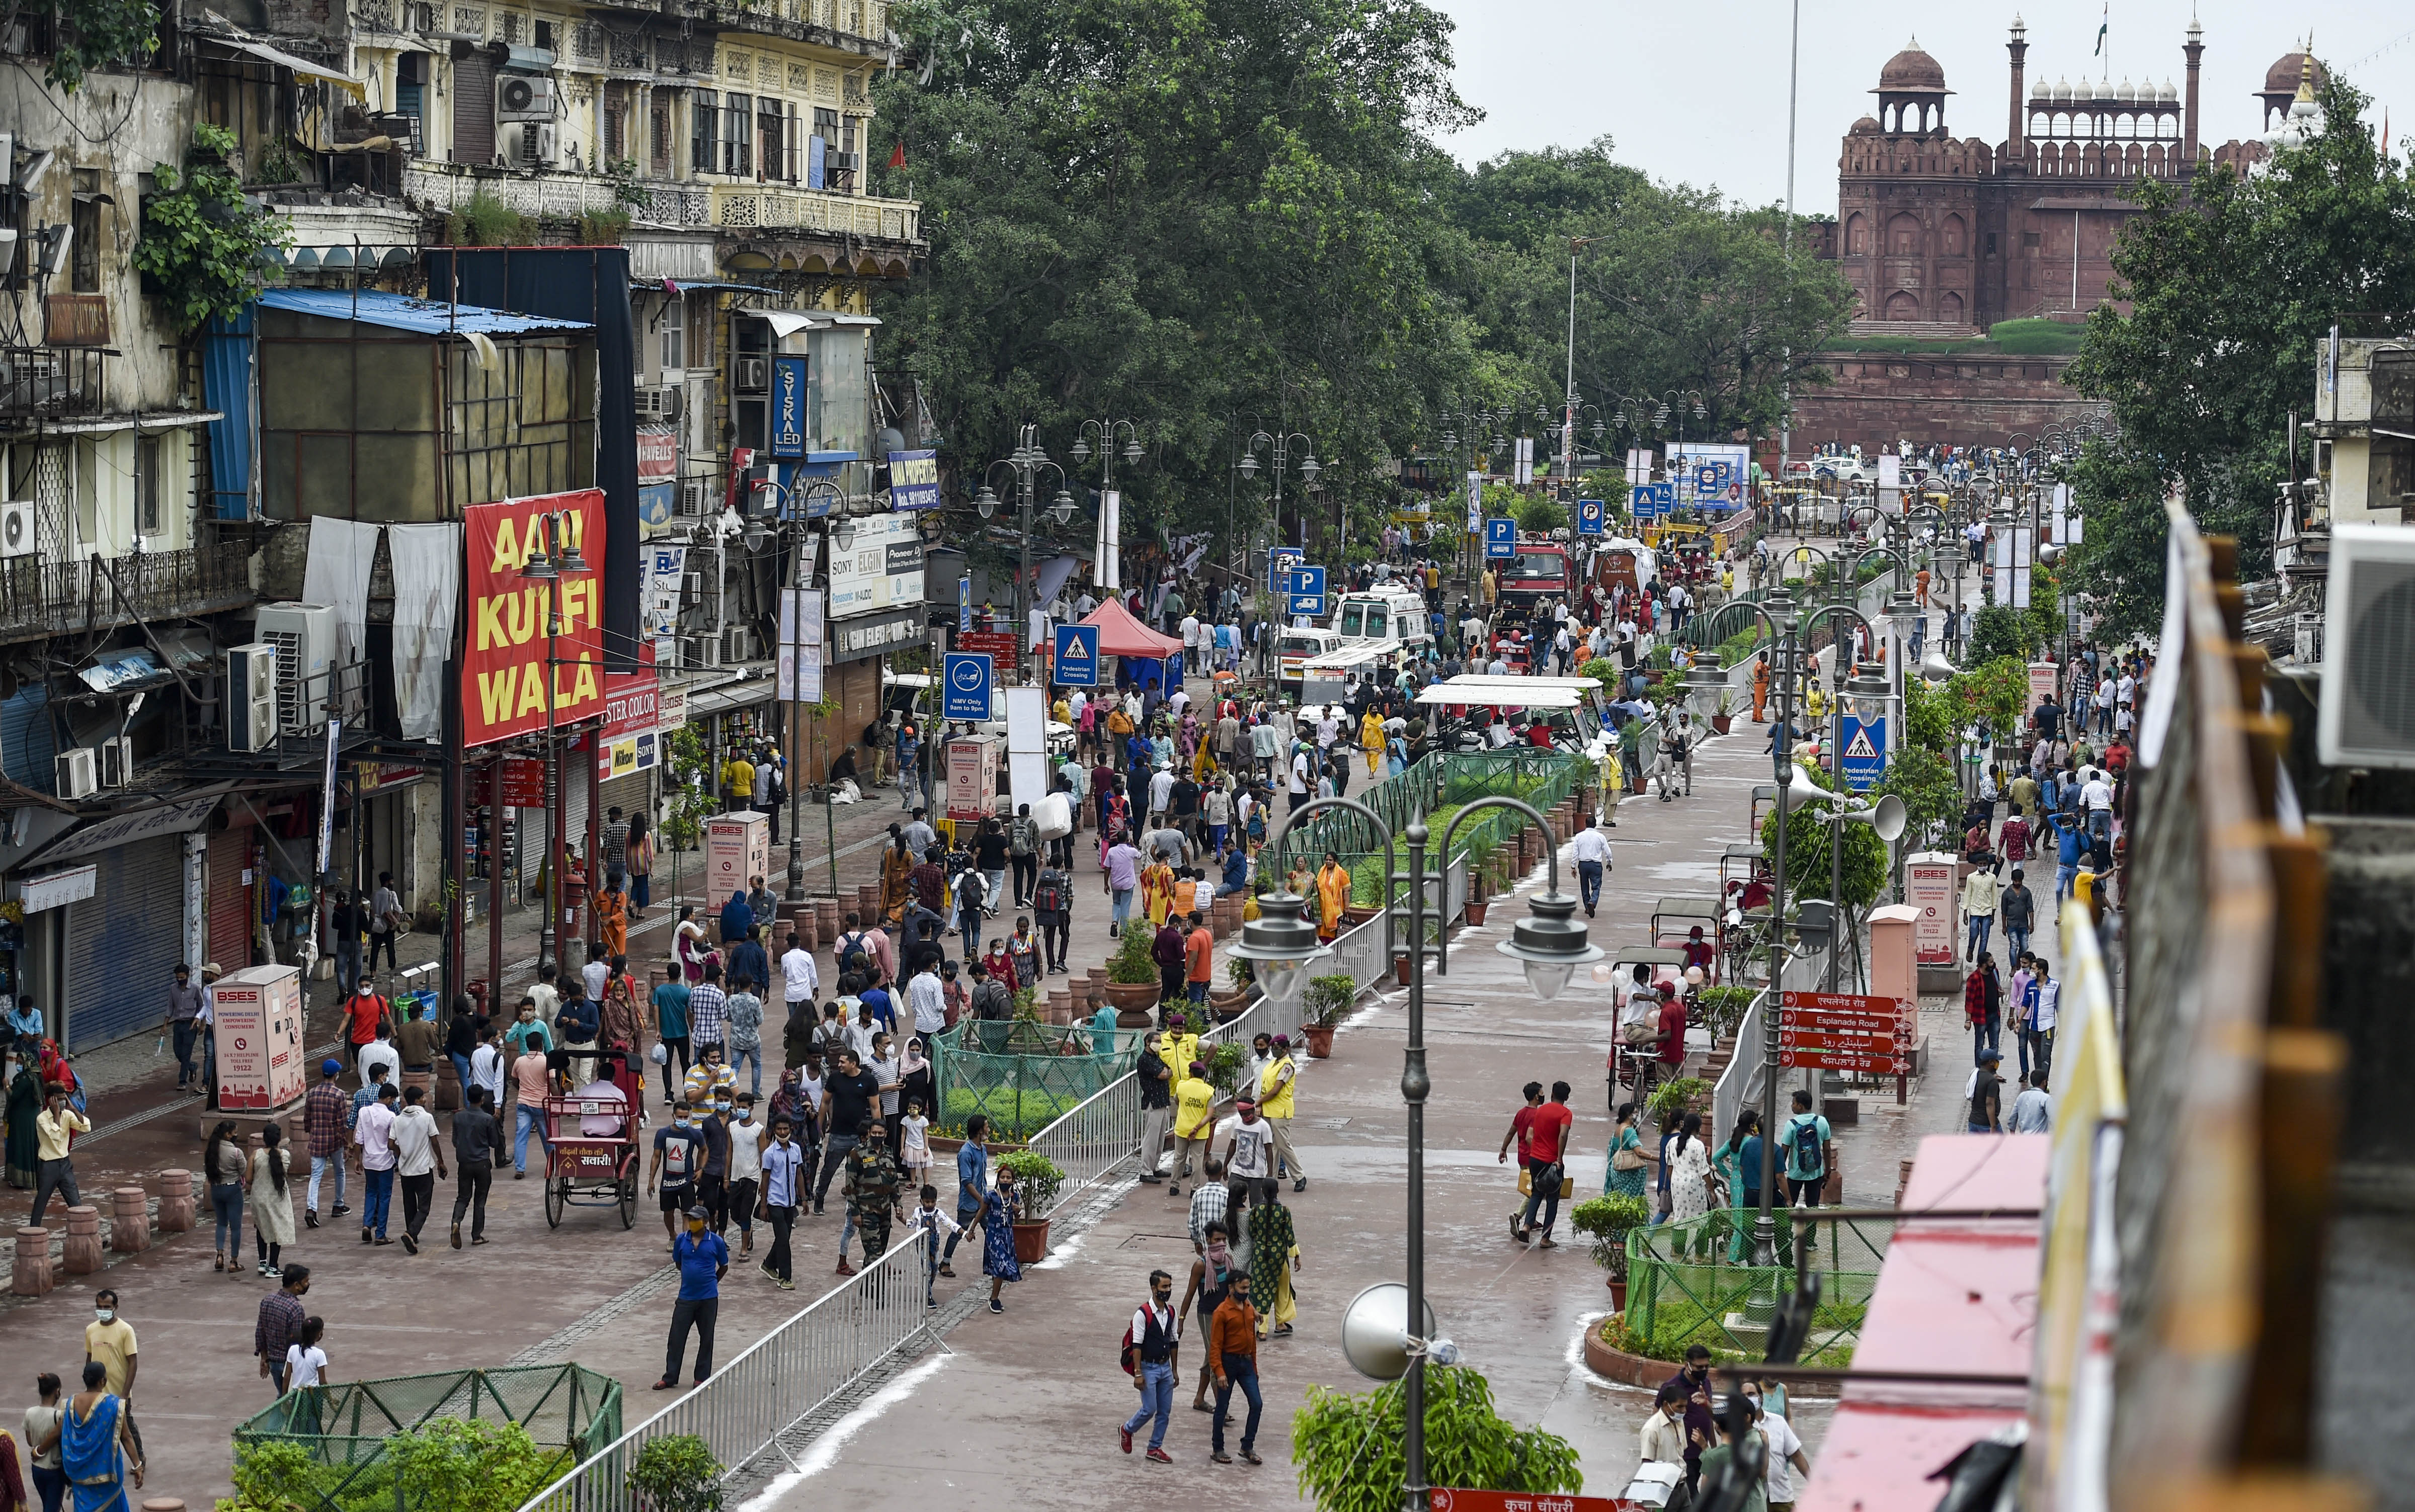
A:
2065 70 2415 635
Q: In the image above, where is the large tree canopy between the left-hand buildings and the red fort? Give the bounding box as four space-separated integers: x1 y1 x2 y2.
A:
872 0 1847 577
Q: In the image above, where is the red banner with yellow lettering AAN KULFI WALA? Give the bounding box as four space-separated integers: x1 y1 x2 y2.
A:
461 488 604 746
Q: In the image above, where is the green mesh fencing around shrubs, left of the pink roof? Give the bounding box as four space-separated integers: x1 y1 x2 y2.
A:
1628 1208 1893 1367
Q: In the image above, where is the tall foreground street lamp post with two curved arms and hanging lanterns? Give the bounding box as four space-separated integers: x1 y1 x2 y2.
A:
1234 795 1601 1512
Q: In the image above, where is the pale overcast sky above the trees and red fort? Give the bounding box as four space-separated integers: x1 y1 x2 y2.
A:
1434 0 2415 215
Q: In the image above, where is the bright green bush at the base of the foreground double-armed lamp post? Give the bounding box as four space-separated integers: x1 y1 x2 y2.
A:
1292 1365 1584 1512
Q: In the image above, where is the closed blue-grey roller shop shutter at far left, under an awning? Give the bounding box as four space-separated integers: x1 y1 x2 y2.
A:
67 835 189 1053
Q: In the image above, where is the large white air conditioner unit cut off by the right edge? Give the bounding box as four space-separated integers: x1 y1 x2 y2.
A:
2313 524 2415 768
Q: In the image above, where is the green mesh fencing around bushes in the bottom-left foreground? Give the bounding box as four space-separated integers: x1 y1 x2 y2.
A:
234 1365 621 1512
